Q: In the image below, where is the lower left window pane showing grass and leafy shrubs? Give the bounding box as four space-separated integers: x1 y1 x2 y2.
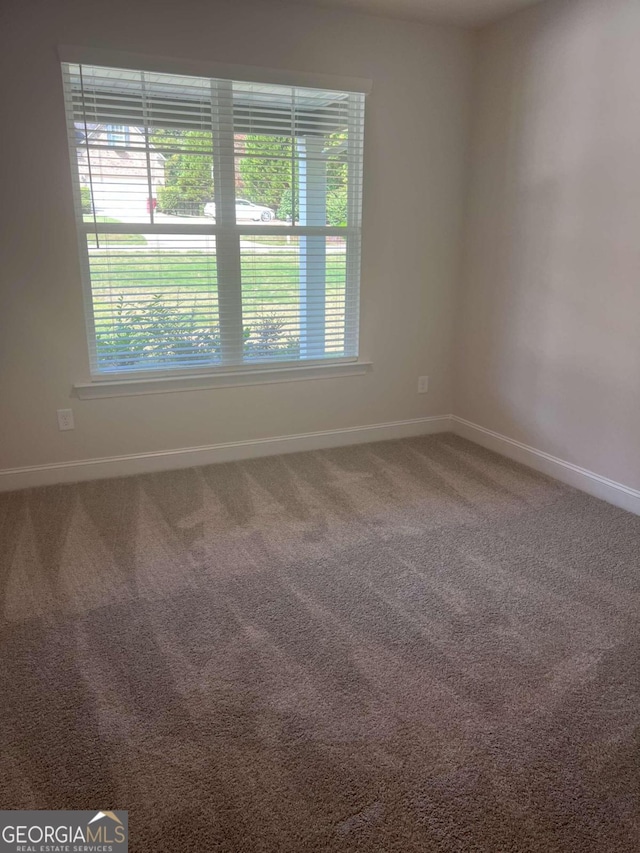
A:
87 233 220 370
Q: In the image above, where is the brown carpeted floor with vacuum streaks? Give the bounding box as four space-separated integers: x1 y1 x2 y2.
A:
0 434 640 853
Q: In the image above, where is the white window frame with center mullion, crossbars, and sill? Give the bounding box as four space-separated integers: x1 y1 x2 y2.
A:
59 48 372 398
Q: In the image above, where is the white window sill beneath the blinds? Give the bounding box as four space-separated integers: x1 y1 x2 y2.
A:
73 361 373 400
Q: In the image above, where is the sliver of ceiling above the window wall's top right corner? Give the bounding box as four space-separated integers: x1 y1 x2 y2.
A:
296 0 540 27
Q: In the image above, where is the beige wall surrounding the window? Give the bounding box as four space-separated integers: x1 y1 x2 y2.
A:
0 0 472 469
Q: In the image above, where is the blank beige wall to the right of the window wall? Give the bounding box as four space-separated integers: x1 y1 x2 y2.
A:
454 0 640 488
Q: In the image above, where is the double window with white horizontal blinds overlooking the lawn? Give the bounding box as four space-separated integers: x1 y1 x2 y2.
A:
63 63 364 379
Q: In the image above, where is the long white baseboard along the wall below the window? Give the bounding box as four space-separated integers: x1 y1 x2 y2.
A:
0 415 451 492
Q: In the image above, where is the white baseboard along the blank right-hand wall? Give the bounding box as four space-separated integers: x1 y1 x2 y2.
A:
451 415 640 515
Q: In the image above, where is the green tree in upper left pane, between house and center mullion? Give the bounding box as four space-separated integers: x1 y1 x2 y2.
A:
151 130 213 214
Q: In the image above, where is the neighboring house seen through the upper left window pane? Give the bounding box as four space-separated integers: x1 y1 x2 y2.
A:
76 124 165 219
